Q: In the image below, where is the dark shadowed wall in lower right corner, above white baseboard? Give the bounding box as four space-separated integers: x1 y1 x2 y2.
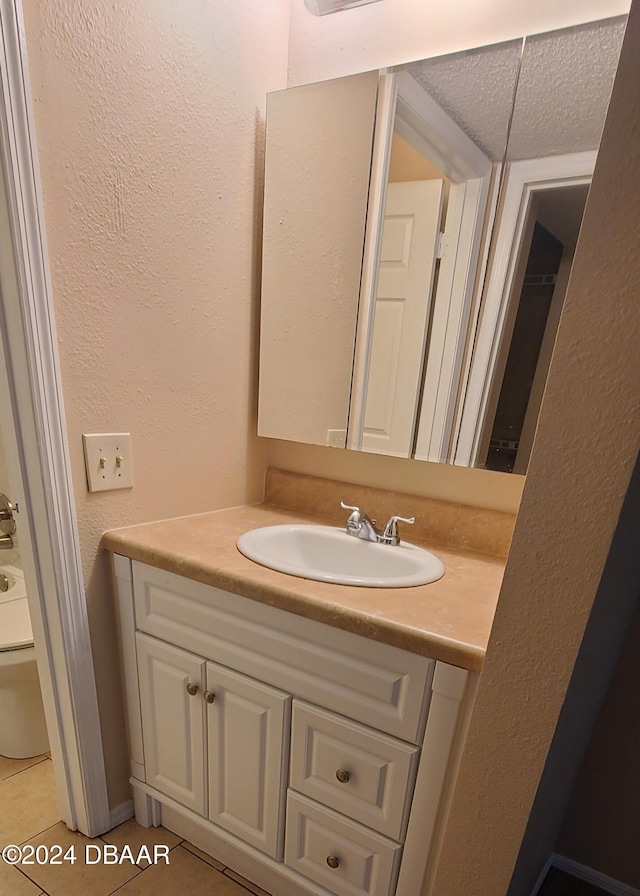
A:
509 461 640 896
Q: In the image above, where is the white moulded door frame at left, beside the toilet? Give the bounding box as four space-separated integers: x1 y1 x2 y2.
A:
0 0 111 836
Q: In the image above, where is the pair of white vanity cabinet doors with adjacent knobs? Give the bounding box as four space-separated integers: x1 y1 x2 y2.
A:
136 632 291 858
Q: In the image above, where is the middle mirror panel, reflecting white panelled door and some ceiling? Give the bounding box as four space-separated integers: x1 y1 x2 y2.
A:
347 41 521 457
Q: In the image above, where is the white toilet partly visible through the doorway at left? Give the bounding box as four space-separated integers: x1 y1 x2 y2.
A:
0 566 49 759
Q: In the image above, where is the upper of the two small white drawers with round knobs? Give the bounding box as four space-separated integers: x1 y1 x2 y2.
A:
291 700 419 840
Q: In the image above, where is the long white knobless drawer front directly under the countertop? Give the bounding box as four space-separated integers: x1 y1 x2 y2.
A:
133 562 434 743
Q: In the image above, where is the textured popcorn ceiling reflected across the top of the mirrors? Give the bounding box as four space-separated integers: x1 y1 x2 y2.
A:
402 16 626 161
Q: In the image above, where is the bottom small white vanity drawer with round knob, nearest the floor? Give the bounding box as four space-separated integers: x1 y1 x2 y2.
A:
285 791 402 896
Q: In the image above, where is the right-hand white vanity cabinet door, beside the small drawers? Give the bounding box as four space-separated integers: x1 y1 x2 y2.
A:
207 663 291 859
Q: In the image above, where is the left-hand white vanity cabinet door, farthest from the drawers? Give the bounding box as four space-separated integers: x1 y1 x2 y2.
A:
136 633 206 815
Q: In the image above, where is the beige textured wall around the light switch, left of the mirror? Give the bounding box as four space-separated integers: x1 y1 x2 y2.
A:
24 0 289 805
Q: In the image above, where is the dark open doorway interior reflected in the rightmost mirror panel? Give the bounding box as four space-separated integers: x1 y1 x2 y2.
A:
480 185 588 473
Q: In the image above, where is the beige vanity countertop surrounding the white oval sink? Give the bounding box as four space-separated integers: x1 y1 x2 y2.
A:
102 504 504 670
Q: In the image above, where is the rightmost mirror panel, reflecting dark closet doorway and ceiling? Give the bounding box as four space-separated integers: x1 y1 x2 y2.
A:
453 17 626 473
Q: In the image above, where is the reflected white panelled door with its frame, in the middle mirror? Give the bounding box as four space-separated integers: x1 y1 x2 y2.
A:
348 67 501 459
